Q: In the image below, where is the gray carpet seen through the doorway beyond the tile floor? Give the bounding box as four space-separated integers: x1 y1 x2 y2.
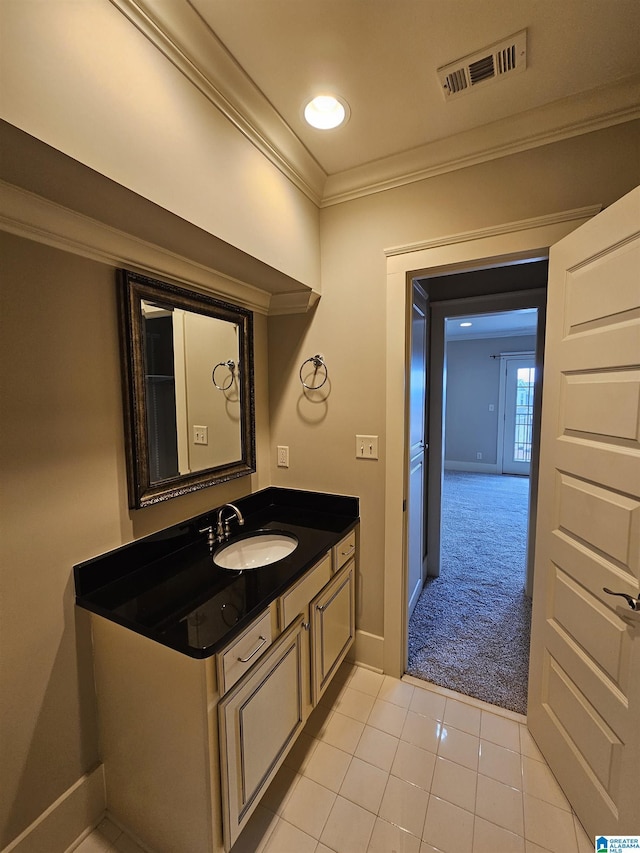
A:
407 471 531 714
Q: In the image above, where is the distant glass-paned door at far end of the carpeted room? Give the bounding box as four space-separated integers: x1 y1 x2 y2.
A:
502 356 536 476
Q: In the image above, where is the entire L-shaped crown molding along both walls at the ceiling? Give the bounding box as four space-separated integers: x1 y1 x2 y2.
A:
105 0 640 208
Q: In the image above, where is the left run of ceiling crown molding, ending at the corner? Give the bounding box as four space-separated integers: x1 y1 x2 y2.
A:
110 0 327 205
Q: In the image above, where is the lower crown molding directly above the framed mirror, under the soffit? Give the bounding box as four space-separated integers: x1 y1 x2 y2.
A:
0 181 284 314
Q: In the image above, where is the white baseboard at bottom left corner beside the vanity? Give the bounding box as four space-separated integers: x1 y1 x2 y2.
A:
2 764 106 853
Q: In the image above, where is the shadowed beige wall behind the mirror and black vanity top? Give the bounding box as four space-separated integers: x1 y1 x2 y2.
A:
0 232 269 853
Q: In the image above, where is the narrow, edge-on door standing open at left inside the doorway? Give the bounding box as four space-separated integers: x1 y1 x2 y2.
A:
407 284 427 619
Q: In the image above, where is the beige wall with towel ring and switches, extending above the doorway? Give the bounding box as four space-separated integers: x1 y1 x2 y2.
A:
269 122 640 636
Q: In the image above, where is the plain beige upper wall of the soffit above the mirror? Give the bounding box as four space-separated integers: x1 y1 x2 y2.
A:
0 0 320 288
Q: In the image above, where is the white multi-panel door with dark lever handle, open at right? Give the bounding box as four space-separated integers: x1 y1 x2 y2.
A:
525 187 640 836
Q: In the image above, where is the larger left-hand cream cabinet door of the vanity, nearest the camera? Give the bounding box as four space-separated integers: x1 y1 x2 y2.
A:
218 619 307 850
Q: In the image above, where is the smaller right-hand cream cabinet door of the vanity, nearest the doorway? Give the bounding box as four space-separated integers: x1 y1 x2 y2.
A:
310 560 356 706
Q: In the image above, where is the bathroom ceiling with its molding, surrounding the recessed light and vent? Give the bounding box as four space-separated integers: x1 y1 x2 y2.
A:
122 0 640 204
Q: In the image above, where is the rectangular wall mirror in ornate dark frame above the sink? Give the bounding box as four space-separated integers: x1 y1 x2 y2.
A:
118 270 256 509
